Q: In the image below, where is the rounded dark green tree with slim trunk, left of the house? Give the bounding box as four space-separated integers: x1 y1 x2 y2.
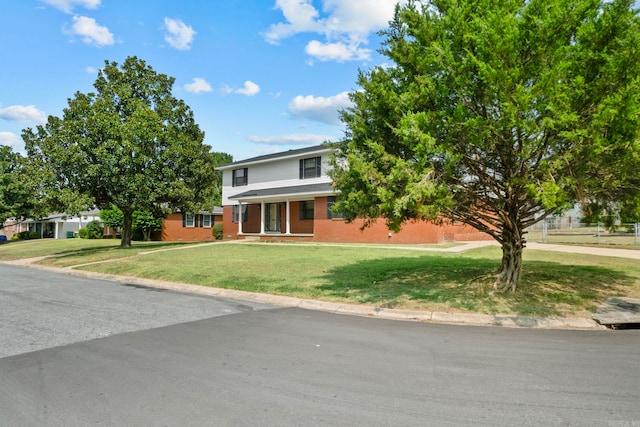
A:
23 57 215 251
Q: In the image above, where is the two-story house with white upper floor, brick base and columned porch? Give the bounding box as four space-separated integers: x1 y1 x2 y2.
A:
217 145 491 244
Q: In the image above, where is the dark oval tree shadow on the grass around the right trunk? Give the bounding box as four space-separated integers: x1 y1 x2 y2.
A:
317 256 637 316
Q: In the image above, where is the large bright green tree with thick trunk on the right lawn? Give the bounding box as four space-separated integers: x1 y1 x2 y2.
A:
333 0 640 291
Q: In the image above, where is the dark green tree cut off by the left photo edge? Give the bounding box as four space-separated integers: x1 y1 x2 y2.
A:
0 145 34 228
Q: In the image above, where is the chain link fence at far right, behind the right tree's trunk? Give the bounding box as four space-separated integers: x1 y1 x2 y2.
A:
527 217 640 246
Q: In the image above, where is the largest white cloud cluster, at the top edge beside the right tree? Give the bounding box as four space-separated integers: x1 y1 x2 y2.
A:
264 0 406 61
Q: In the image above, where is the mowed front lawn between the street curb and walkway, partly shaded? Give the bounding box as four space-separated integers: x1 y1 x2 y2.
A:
27 243 640 317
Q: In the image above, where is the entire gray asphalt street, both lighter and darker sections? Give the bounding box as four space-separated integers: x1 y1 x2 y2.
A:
0 266 640 427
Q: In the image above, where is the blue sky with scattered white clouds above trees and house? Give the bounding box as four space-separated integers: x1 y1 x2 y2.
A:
0 0 396 160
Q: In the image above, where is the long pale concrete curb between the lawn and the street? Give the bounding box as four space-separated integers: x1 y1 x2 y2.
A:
4 260 607 330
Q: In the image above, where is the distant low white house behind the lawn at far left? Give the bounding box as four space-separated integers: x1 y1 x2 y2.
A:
2 210 100 239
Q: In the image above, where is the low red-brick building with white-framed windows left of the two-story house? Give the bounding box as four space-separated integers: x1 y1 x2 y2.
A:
160 206 222 241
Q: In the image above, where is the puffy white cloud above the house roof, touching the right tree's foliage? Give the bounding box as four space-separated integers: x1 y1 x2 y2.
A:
289 92 353 125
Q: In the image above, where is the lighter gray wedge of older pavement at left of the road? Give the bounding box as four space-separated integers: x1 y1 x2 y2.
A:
0 264 273 360
